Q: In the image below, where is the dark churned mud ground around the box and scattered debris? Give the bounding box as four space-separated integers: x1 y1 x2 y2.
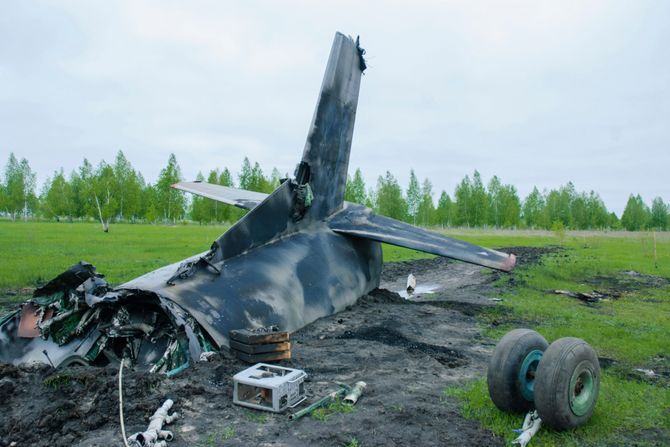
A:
0 247 556 447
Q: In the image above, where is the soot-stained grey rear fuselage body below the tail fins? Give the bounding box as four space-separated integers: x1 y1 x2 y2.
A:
120 229 382 346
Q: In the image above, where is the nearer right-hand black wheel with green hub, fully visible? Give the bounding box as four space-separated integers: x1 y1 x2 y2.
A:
535 337 600 430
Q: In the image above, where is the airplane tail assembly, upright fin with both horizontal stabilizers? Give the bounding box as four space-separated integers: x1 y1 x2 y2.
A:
173 33 516 271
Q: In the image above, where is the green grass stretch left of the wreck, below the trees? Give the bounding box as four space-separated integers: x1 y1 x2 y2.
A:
0 221 225 289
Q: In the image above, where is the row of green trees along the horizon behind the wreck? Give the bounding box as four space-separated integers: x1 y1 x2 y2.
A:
0 151 670 231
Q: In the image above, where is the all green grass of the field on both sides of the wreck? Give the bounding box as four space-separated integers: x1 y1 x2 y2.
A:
0 221 670 446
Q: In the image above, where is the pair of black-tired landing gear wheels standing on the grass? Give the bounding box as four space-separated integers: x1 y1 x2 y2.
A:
487 329 600 430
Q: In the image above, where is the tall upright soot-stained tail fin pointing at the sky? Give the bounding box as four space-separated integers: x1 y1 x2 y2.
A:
299 33 365 219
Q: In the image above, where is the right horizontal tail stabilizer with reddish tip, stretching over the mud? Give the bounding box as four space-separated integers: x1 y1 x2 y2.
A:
328 205 516 272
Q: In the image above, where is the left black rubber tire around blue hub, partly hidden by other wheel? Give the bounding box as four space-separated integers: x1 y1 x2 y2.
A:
486 329 549 413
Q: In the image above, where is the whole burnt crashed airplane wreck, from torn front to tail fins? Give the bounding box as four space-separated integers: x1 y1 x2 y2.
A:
0 33 515 375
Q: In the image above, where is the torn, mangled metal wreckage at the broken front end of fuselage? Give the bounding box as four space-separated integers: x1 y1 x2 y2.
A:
0 262 214 375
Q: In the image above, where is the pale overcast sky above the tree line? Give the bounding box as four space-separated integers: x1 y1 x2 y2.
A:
0 0 670 215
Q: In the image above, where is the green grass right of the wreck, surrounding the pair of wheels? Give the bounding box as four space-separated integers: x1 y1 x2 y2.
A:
445 229 670 446
